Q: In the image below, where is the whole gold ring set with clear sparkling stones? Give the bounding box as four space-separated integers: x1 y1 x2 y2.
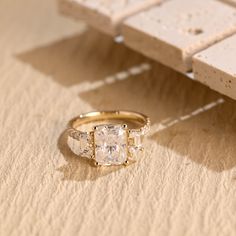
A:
67 111 150 166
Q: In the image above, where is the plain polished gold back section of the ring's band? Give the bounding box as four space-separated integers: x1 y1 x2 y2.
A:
69 111 149 128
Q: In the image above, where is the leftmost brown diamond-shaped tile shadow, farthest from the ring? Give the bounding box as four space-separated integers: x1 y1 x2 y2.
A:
16 29 145 86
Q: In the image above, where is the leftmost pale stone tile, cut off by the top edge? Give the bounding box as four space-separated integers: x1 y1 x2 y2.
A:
58 0 161 35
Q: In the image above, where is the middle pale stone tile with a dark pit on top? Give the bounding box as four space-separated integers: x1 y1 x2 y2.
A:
122 0 236 73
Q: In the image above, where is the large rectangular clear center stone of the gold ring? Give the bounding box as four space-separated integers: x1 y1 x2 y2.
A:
94 125 128 165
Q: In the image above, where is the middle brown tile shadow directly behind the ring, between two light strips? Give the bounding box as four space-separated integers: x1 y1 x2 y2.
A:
79 58 221 124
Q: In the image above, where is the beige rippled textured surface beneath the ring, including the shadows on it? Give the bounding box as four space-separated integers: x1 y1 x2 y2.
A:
0 0 236 236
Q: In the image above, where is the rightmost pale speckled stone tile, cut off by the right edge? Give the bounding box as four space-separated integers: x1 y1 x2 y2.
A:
193 35 236 99
